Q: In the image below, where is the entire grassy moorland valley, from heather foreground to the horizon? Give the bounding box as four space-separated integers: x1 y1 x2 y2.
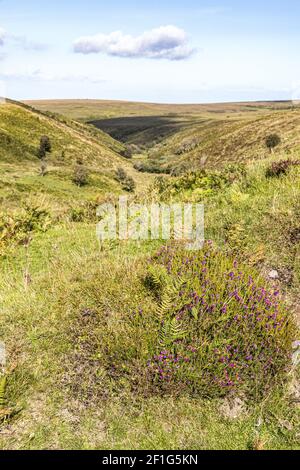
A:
0 96 300 450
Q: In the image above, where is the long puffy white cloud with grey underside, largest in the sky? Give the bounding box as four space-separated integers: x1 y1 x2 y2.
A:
73 26 194 60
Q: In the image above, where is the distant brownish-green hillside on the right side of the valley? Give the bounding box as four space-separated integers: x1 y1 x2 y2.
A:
152 109 300 171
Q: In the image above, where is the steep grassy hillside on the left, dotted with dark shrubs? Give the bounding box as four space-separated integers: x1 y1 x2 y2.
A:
0 102 152 211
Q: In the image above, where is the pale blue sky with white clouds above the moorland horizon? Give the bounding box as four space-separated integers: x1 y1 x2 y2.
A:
0 0 300 103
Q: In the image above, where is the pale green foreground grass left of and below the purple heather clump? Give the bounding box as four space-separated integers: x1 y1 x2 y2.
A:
0 224 297 449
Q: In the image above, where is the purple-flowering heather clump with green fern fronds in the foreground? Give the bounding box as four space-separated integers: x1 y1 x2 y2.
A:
142 243 295 397
